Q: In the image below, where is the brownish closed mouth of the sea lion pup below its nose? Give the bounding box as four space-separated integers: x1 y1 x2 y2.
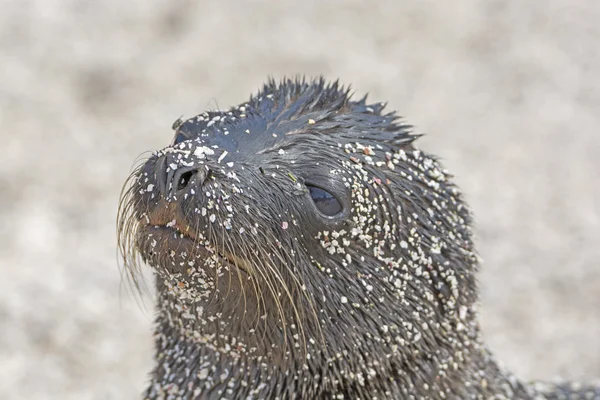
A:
138 221 252 275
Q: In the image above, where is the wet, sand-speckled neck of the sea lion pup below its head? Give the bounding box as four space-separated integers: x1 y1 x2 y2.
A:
145 282 535 399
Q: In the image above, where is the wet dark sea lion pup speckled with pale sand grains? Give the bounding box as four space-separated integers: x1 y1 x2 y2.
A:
118 79 600 399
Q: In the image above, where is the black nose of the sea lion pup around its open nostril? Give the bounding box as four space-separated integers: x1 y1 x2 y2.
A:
156 156 210 199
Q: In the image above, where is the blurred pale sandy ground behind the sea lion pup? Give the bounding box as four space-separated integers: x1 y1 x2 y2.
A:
0 0 600 399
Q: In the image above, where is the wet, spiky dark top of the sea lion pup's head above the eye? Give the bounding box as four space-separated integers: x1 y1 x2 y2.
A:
166 79 417 166
